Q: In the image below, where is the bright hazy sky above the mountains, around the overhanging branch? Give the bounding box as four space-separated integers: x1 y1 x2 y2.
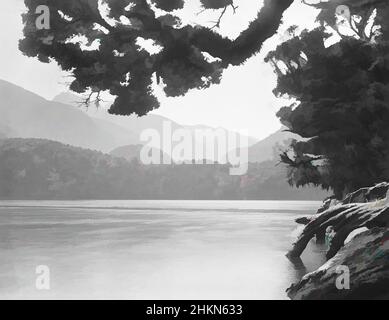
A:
0 0 315 138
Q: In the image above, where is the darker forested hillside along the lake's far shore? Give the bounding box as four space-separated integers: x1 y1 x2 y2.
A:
0 139 327 200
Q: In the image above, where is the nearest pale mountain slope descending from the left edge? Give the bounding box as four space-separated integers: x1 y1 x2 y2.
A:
0 80 138 152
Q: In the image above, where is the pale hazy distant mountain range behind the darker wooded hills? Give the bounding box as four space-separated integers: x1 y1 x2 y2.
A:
0 80 298 168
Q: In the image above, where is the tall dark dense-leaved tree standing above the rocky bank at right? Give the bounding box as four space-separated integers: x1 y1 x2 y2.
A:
266 0 389 198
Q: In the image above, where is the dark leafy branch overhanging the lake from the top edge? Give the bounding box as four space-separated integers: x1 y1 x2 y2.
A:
20 0 293 116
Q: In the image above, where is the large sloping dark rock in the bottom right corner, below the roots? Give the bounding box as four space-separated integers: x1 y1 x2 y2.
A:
287 228 389 300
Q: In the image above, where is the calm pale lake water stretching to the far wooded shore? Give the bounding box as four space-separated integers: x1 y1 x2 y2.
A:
0 201 324 299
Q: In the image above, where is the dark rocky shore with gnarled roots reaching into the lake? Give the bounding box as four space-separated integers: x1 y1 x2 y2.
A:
287 183 389 300
